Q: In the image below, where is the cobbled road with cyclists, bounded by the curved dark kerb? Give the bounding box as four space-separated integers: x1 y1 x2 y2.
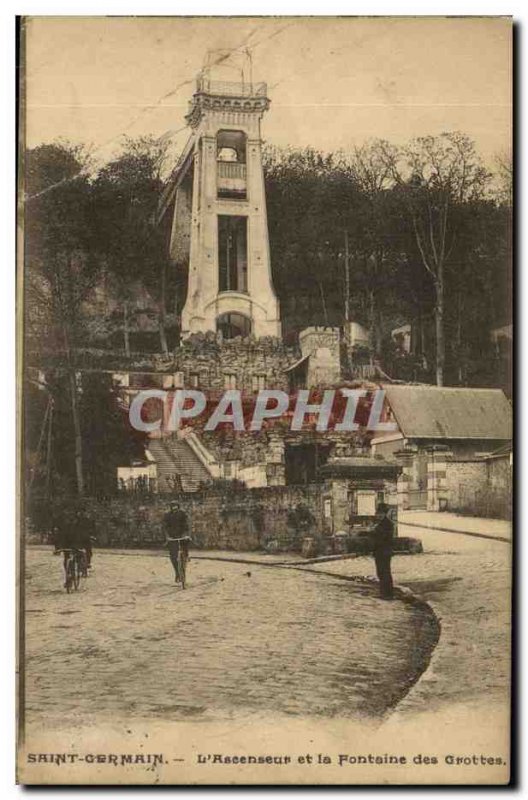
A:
26 549 434 731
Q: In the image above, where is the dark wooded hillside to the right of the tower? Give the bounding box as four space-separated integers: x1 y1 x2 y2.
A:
264 138 511 388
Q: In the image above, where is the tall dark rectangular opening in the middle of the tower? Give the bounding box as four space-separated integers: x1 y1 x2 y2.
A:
218 214 248 292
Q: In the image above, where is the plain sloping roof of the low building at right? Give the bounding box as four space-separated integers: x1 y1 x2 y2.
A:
383 384 512 440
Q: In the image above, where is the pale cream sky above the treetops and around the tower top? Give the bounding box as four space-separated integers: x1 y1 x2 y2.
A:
25 17 512 172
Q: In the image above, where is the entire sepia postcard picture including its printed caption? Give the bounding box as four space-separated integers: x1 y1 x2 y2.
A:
17 16 513 786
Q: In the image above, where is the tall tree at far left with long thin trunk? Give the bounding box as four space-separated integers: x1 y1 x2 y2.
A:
24 142 99 494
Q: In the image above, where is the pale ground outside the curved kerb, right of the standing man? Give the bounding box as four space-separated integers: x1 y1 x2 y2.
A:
306 512 511 717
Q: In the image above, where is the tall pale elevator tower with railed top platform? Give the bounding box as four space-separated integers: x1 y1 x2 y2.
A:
159 52 281 339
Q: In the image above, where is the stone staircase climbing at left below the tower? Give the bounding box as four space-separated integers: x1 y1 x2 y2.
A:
148 436 212 492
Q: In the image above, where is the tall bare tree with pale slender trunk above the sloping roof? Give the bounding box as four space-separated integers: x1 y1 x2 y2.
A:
380 133 489 386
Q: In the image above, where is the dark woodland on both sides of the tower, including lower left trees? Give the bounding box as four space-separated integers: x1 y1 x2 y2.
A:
23 133 512 500
